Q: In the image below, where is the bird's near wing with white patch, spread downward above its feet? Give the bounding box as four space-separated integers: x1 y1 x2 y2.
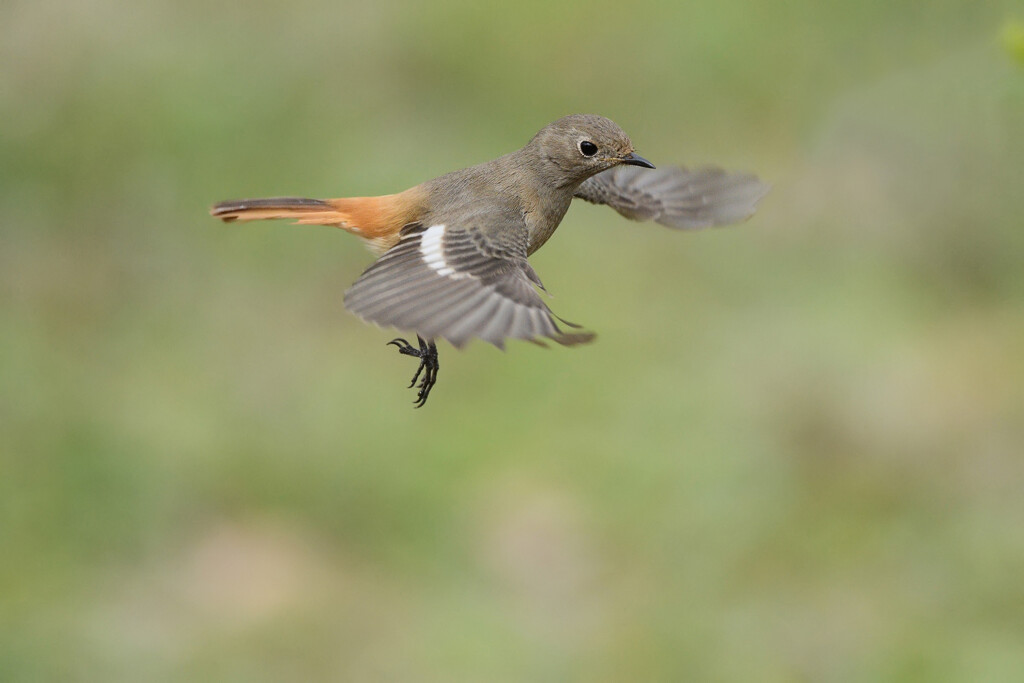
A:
345 214 594 348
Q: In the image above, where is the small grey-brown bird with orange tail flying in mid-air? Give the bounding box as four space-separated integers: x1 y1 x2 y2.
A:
210 114 769 408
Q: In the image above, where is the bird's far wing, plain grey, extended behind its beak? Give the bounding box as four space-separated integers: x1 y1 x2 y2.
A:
575 166 769 229
